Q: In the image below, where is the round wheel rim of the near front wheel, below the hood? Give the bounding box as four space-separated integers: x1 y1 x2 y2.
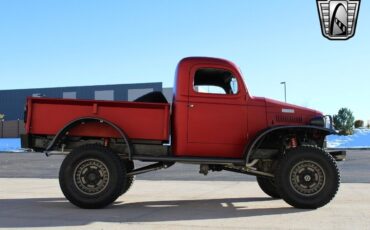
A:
290 160 326 196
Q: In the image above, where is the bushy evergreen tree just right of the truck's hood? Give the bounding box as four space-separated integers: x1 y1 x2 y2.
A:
334 108 355 135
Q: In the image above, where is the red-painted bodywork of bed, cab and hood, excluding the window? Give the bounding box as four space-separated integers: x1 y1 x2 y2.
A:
26 58 321 158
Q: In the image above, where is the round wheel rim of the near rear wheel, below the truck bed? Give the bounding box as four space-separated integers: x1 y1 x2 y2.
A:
73 159 109 195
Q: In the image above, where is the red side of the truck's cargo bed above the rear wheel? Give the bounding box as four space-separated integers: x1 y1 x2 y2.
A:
25 97 170 142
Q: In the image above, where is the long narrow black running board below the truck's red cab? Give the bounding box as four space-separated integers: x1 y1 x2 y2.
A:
132 155 245 165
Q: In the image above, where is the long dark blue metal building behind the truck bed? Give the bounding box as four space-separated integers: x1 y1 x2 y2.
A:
0 82 162 121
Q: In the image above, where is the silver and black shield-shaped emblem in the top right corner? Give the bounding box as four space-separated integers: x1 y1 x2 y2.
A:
317 0 360 40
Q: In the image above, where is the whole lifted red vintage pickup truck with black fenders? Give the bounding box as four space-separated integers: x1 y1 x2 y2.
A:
22 57 341 208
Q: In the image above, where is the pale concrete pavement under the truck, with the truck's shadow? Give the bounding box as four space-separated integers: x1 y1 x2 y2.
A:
0 178 370 229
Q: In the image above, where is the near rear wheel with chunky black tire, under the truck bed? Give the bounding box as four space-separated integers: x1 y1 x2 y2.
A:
59 144 126 209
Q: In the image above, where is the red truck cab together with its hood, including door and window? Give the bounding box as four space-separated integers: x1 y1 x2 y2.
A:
172 57 324 158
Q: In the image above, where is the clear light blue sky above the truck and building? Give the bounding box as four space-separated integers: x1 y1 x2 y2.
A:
0 0 370 122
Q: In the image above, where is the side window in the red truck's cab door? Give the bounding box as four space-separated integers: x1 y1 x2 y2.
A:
193 68 238 94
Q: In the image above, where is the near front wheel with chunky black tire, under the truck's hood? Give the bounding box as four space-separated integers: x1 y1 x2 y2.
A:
275 146 340 209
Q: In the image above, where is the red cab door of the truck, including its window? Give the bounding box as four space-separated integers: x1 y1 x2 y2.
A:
187 66 247 158
